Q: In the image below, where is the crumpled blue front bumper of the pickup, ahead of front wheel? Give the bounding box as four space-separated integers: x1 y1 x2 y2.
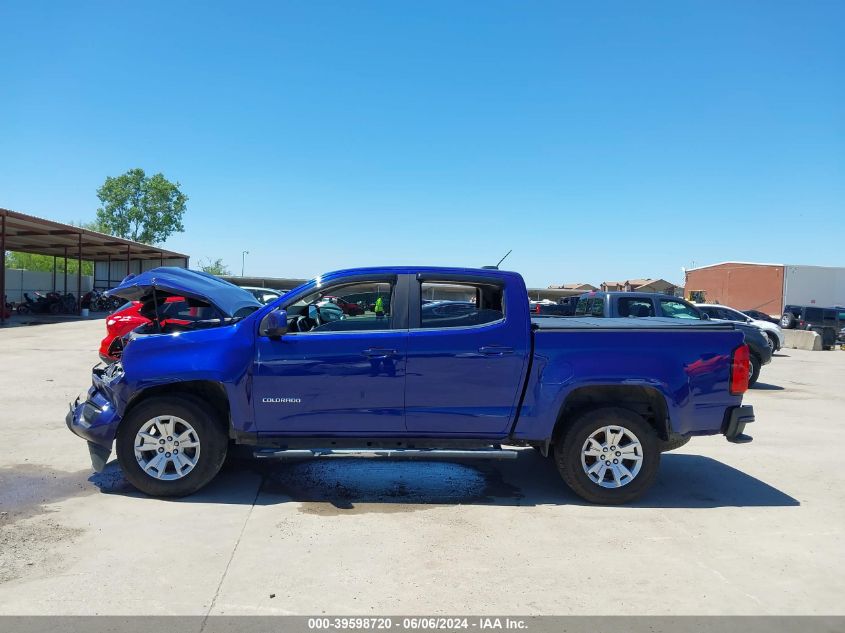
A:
65 367 120 472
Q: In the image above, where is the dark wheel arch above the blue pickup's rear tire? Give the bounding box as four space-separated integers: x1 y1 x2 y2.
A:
552 385 672 443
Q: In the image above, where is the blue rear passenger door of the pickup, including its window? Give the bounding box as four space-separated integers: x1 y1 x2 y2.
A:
405 274 530 437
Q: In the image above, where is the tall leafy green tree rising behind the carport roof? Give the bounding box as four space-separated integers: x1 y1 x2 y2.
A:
96 168 188 244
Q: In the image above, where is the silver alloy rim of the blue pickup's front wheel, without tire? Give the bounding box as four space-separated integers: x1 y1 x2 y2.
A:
135 415 200 481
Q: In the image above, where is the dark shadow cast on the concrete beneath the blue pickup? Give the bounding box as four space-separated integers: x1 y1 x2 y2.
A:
91 449 800 515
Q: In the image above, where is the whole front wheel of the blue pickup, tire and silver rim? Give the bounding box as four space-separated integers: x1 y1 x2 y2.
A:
115 396 228 497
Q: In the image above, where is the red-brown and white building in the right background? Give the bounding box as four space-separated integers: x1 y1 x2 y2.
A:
686 262 845 316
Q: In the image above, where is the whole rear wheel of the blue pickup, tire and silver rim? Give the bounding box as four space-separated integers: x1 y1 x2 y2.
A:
555 407 660 504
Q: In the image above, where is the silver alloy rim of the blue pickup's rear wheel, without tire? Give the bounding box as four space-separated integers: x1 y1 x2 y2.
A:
581 426 643 488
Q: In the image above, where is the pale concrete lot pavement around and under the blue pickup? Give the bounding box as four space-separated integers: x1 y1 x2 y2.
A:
0 321 845 615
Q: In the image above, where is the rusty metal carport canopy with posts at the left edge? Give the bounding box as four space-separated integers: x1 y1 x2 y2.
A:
0 208 188 323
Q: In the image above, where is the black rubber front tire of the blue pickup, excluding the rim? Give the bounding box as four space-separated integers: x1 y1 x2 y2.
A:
115 396 229 497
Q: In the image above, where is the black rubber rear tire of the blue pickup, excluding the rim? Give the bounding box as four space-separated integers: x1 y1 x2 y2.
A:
555 407 660 505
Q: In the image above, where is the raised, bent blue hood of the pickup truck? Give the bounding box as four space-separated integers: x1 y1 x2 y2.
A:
106 266 262 318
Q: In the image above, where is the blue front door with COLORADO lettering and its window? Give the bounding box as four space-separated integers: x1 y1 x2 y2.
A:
253 278 408 437
